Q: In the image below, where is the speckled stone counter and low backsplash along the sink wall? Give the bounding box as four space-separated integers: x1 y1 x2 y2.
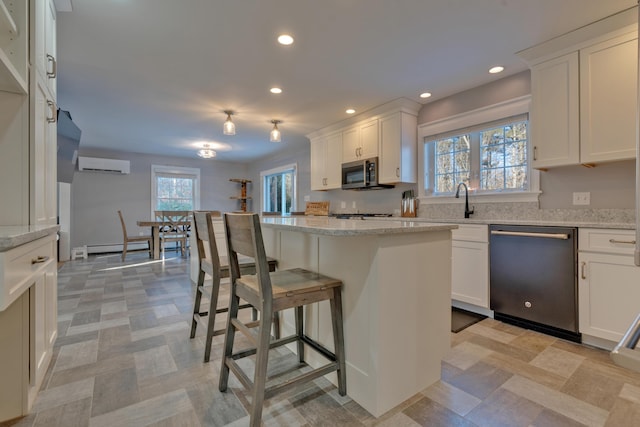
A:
418 201 635 225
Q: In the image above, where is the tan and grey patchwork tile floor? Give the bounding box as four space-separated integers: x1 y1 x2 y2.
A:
2 253 640 427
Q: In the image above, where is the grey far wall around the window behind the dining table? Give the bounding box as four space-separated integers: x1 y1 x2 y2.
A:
71 150 247 251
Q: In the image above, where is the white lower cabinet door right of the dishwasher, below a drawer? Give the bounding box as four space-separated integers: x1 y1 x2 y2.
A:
578 253 640 342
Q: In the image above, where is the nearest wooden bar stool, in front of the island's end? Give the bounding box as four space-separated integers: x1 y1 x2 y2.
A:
219 214 347 426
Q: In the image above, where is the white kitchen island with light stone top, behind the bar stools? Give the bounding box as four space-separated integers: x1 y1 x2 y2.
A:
262 217 457 417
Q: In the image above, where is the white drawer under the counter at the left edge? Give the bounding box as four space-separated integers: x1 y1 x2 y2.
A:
0 234 56 311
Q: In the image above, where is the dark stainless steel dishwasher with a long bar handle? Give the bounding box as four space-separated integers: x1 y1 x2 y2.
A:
489 225 580 342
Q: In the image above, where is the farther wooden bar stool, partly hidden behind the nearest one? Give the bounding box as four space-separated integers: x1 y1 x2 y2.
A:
190 211 280 362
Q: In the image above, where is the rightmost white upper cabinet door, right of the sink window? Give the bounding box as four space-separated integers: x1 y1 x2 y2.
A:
580 33 638 163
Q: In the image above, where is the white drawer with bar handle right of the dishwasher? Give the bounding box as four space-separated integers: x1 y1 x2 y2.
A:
578 228 636 255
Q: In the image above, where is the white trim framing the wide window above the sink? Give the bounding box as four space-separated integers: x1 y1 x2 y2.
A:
418 95 540 204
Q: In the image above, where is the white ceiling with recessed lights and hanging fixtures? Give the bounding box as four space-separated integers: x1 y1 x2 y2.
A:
56 0 637 162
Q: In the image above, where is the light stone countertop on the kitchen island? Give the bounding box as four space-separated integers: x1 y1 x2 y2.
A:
261 216 458 236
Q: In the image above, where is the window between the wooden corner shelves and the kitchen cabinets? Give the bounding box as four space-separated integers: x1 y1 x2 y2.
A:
260 164 297 214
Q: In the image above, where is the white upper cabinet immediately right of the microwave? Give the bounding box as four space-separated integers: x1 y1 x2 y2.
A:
380 111 418 184
